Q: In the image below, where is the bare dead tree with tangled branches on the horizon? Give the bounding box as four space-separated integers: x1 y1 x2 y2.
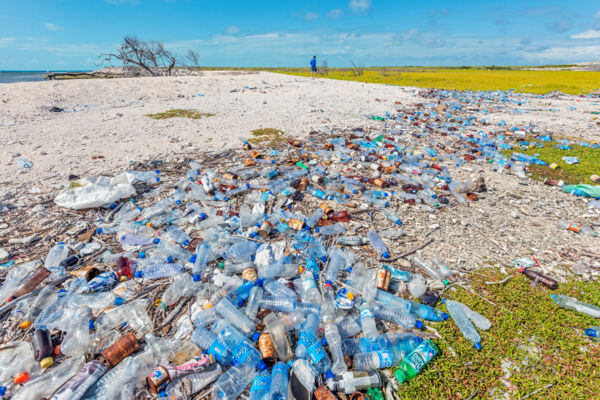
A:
100 36 177 76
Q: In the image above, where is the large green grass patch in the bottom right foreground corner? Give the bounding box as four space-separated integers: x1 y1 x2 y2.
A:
397 269 600 399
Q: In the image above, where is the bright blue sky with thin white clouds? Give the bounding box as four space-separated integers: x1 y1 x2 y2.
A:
0 0 600 70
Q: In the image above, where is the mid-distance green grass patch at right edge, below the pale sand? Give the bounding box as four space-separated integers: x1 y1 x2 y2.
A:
503 142 600 185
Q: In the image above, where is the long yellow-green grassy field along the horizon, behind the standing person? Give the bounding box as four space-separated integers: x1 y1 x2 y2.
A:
274 67 600 95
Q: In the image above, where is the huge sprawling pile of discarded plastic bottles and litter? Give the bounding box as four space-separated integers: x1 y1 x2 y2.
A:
0 92 600 400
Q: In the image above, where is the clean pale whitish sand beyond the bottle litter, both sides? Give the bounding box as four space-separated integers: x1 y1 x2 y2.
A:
0 71 600 191
